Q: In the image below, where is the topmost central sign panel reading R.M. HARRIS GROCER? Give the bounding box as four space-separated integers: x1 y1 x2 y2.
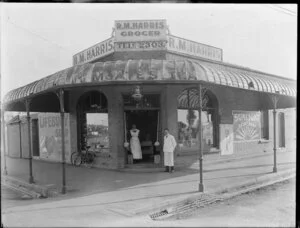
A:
115 20 167 42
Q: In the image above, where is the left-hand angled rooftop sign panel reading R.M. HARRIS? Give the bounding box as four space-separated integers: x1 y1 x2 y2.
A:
73 38 114 66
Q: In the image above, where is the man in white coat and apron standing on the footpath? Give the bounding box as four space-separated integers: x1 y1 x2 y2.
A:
163 128 177 172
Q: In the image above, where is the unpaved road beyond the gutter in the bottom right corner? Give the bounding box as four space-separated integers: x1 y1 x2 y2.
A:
101 179 296 227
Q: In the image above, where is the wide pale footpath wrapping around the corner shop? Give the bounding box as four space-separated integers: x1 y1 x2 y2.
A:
2 152 296 227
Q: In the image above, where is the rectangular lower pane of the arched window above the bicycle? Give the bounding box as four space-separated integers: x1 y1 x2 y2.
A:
86 113 109 151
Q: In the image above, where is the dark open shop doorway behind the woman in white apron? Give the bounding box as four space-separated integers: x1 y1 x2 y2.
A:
125 110 159 163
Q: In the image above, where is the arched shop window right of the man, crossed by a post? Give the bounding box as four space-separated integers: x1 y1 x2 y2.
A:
177 88 218 152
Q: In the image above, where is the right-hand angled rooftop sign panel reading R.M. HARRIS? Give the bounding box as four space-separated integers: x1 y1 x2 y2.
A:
167 35 223 61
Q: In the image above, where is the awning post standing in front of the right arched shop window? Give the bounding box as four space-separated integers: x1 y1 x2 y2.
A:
198 84 204 192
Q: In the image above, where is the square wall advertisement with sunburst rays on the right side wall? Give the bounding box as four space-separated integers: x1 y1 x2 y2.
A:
233 111 261 141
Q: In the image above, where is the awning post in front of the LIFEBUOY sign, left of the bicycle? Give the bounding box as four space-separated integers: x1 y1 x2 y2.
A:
57 89 66 194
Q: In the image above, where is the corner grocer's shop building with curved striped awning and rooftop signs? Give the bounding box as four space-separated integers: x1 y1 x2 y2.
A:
4 20 296 172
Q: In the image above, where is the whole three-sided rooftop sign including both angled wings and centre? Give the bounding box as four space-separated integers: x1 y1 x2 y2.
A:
73 20 223 65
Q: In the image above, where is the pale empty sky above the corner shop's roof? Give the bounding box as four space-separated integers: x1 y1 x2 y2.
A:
0 3 297 96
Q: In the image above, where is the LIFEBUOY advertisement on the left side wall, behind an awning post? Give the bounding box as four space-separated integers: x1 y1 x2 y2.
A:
38 113 71 162
